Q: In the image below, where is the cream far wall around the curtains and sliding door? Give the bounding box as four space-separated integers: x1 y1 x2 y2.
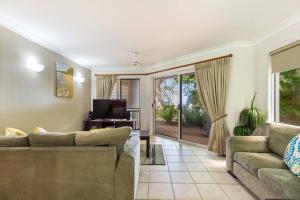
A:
91 44 254 135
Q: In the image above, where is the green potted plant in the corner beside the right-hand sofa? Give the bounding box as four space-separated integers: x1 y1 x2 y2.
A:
233 93 266 136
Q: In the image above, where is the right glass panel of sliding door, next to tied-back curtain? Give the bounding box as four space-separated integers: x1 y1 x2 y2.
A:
181 73 211 145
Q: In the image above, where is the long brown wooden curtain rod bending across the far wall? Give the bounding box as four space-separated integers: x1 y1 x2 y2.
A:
95 54 233 76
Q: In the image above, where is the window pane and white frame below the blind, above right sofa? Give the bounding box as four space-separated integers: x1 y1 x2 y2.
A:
272 68 300 126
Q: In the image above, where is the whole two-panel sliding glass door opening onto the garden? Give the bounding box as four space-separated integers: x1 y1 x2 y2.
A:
154 73 211 145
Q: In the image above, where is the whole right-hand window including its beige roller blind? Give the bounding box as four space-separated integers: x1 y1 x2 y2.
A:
270 40 300 126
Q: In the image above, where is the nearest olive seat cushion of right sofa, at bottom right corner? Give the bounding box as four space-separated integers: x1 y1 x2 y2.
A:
258 168 300 199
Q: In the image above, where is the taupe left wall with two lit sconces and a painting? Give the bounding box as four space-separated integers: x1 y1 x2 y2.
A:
0 26 91 132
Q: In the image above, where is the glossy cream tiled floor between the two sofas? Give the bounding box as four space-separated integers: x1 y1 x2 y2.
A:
136 136 255 200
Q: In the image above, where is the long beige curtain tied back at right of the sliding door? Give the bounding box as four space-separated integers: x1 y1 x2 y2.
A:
195 57 230 155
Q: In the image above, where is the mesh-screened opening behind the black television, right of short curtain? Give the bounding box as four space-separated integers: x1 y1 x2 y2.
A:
120 79 141 129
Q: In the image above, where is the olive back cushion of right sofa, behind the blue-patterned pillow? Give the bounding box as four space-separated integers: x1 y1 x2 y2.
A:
269 123 300 157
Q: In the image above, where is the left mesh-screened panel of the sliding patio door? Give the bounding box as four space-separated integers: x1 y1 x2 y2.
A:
155 76 180 138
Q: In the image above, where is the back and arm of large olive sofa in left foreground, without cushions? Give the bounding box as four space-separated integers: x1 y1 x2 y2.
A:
0 128 140 200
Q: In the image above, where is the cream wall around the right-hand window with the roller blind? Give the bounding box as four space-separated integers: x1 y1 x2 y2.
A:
254 22 300 120
